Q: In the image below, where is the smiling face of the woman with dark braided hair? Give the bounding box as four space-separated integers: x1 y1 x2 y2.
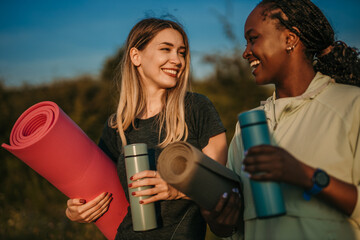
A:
243 6 288 85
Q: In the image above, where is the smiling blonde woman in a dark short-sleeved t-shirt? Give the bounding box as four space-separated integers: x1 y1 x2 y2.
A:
66 18 227 240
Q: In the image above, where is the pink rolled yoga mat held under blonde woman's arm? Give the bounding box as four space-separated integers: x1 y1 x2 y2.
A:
1 101 129 239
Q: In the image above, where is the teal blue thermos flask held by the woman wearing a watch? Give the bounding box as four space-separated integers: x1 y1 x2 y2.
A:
238 110 286 218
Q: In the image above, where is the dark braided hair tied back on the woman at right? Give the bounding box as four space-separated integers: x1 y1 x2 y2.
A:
258 0 360 86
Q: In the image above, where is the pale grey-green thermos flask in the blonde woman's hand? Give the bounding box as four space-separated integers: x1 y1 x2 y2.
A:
124 143 157 231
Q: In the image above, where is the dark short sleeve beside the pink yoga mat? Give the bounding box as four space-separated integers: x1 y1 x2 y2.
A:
98 117 120 163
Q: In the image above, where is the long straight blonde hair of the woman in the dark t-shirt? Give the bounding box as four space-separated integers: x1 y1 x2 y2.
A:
110 18 190 148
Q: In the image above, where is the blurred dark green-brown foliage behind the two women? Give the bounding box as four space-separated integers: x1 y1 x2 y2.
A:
0 15 272 240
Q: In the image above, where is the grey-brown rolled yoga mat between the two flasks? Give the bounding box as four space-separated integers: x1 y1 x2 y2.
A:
157 142 240 210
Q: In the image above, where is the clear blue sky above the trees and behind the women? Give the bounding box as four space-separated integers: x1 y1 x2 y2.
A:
0 0 360 86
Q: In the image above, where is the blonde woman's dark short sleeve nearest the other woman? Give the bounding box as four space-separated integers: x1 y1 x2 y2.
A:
185 93 226 149
